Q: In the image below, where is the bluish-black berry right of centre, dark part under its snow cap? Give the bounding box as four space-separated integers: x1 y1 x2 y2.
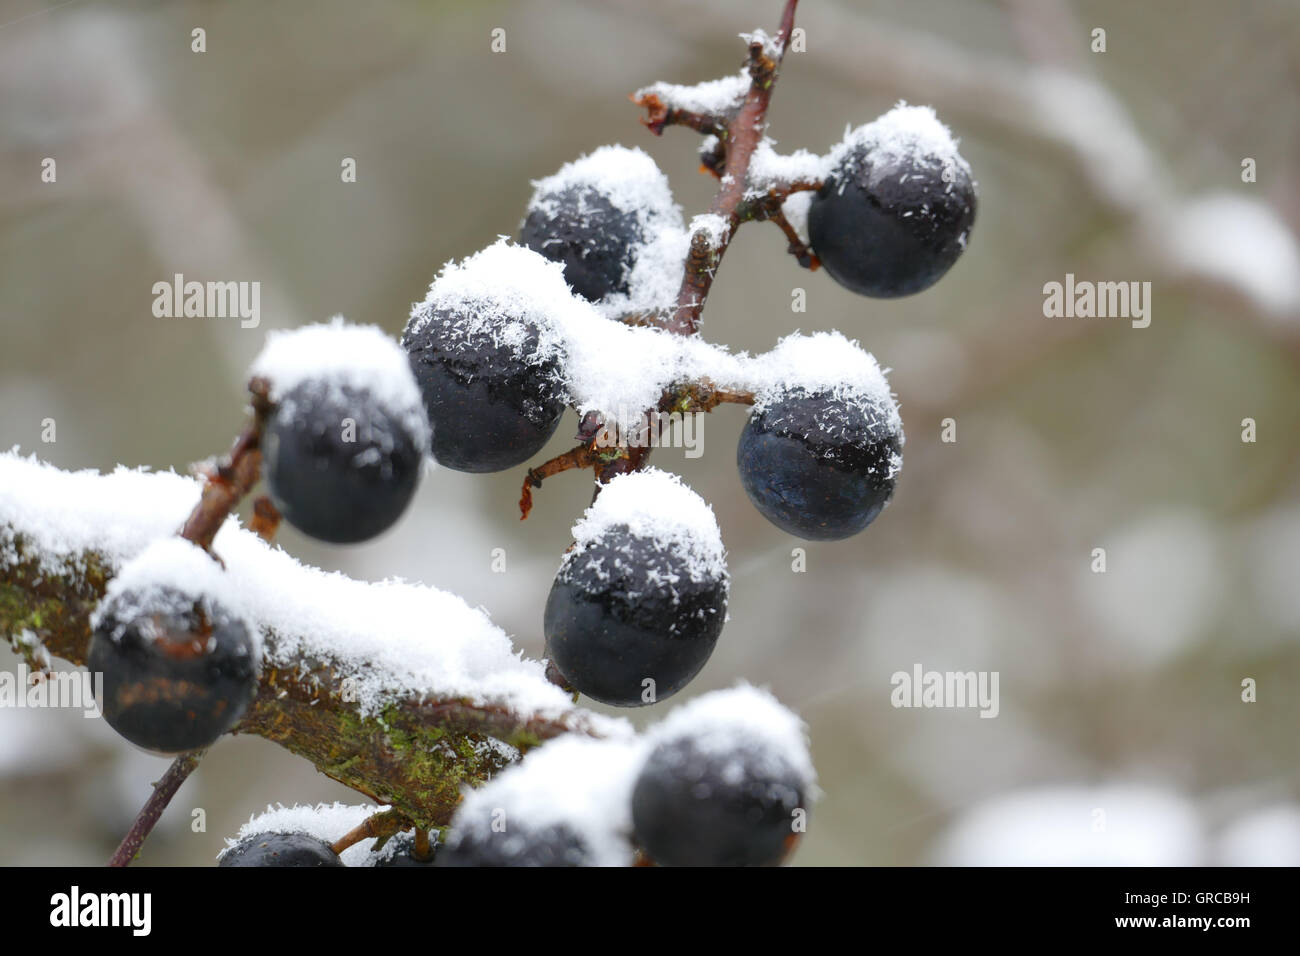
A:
736 390 902 541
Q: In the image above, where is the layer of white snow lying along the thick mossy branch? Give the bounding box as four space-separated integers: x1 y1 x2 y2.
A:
0 453 619 730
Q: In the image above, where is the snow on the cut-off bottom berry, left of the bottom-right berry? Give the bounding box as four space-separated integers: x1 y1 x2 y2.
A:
451 736 645 866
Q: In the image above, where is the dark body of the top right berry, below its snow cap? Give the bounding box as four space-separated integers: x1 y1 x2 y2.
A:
809 136 975 298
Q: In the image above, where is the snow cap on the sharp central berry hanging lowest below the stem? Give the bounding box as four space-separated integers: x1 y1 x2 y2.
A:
564 468 727 583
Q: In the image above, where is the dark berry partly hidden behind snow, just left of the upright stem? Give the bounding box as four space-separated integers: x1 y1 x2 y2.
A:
519 183 645 302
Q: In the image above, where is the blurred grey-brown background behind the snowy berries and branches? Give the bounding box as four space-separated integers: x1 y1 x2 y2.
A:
0 0 1300 865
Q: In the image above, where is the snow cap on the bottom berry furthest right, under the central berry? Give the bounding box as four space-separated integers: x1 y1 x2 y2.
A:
645 683 816 799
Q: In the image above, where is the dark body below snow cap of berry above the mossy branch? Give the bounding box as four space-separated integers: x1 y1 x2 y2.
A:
263 381 428 544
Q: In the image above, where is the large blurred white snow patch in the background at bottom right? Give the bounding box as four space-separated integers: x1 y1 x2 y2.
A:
936 786 1204 866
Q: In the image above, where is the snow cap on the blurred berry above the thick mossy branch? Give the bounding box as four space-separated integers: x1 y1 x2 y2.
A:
248 316 428 437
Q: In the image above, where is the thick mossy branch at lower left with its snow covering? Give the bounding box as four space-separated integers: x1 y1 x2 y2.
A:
0 451 621 827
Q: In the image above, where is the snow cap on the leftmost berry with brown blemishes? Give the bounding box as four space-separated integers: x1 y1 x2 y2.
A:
91 535 260 658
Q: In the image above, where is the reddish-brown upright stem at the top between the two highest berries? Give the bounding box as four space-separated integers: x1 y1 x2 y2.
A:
666 0 798 336
